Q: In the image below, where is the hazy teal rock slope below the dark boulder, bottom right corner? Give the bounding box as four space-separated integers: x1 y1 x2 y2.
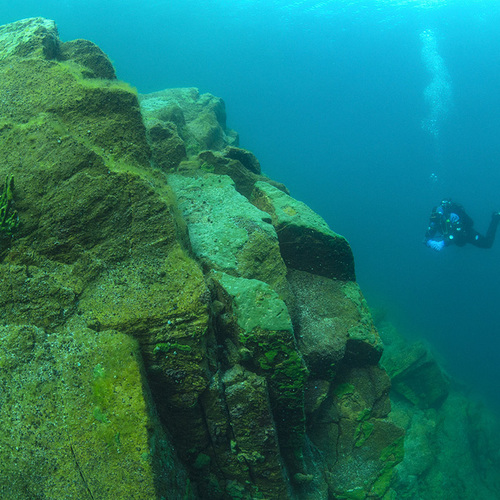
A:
392 376 500 500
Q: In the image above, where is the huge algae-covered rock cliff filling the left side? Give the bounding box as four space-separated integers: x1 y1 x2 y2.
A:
0 18 403 500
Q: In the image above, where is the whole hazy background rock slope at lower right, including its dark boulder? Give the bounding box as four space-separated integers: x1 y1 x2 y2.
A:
377 321 500 500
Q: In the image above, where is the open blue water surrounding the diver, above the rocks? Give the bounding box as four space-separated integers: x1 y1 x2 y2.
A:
0 0 500 407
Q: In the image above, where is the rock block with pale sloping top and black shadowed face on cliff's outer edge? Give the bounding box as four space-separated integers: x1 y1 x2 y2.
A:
251 182 355 281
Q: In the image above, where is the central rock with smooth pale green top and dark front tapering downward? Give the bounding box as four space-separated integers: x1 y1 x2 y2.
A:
212 272 306 472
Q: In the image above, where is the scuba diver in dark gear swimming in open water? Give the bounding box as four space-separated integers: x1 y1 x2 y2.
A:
424 199 500 252
